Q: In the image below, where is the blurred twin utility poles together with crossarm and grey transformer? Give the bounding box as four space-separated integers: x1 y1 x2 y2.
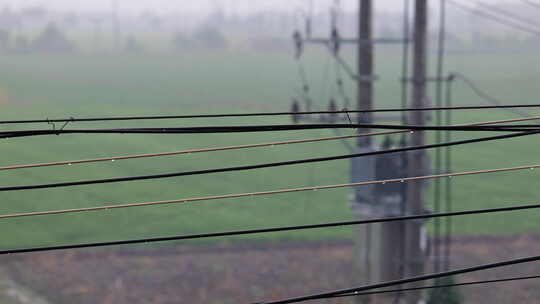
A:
293 0 427 304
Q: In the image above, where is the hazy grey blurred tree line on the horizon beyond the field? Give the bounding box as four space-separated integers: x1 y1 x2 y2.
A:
0 5 540 54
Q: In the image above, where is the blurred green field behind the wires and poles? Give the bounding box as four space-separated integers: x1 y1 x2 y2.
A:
0 50 540 248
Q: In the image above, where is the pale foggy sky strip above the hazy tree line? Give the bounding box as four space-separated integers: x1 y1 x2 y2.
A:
0 0 510 14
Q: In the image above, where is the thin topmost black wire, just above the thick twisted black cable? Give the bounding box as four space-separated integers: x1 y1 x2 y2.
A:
0 104 540 124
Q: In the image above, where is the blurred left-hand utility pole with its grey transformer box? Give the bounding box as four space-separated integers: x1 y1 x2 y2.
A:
351 0 408 304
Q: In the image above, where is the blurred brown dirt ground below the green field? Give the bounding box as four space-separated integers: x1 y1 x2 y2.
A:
1 235 540 304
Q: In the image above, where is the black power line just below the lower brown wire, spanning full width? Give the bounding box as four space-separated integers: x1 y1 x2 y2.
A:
0 204 540 255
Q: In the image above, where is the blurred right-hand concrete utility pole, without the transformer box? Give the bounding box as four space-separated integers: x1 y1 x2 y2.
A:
405 0 428 304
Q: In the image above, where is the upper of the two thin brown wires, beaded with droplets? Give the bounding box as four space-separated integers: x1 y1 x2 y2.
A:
4 116 540 171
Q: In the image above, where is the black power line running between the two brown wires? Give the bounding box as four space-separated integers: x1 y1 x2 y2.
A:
0 131 540 192
